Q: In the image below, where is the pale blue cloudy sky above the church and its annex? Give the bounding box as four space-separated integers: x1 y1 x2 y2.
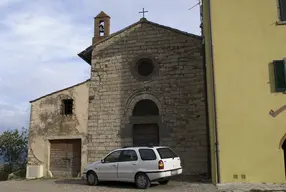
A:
0 0 200 132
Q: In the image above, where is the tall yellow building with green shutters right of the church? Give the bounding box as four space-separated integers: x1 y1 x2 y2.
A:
202 0 286 183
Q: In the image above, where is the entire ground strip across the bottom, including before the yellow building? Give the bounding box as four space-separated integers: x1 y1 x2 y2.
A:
0 179 286 192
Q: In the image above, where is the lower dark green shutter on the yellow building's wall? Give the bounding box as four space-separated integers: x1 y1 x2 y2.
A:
273 60 286 92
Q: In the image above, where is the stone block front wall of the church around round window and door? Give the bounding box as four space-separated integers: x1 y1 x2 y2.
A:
88 22 209 175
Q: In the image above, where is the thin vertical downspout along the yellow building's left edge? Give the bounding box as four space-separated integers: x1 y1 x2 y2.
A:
208 0 220 183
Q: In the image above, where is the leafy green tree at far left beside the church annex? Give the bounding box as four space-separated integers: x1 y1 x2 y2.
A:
0 128 28 173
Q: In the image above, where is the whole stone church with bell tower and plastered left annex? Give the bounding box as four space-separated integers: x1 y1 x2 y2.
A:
27 12 210 178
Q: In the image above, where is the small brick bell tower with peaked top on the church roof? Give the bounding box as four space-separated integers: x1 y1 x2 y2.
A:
92 11 110 44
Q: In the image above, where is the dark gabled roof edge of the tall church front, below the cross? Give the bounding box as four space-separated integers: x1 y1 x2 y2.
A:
78 18 202 64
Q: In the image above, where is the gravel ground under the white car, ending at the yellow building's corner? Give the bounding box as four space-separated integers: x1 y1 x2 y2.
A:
0 179 217 192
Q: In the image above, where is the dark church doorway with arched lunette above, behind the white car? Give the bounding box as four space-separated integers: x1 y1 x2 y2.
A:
132 99 160 146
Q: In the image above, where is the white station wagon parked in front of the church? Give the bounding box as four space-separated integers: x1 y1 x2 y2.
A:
82 146 183 189
